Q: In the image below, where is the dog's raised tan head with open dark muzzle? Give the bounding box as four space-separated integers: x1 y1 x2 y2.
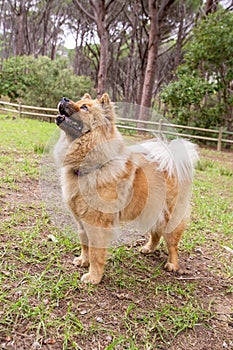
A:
56 93 114 139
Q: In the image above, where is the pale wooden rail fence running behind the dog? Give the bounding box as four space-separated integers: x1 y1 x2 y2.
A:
0 101 233 151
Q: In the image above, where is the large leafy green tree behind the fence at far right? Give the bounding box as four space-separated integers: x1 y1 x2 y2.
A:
160 10 233 130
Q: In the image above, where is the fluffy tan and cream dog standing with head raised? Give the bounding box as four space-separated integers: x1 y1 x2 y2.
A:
54 93 198 284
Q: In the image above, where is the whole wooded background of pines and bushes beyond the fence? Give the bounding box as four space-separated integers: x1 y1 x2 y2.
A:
0 0 233 131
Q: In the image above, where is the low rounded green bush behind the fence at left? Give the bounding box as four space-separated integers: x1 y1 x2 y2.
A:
0 56 92 107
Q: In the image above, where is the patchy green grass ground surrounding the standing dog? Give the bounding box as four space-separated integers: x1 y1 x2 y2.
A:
0 117 233 350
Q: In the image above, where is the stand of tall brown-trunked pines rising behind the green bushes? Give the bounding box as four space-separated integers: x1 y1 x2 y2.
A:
0 0 223 106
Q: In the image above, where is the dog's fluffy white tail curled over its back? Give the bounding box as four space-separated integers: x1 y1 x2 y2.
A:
133 139 199 183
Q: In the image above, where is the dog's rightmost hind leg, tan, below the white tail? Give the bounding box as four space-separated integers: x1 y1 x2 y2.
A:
163 219 186 271
